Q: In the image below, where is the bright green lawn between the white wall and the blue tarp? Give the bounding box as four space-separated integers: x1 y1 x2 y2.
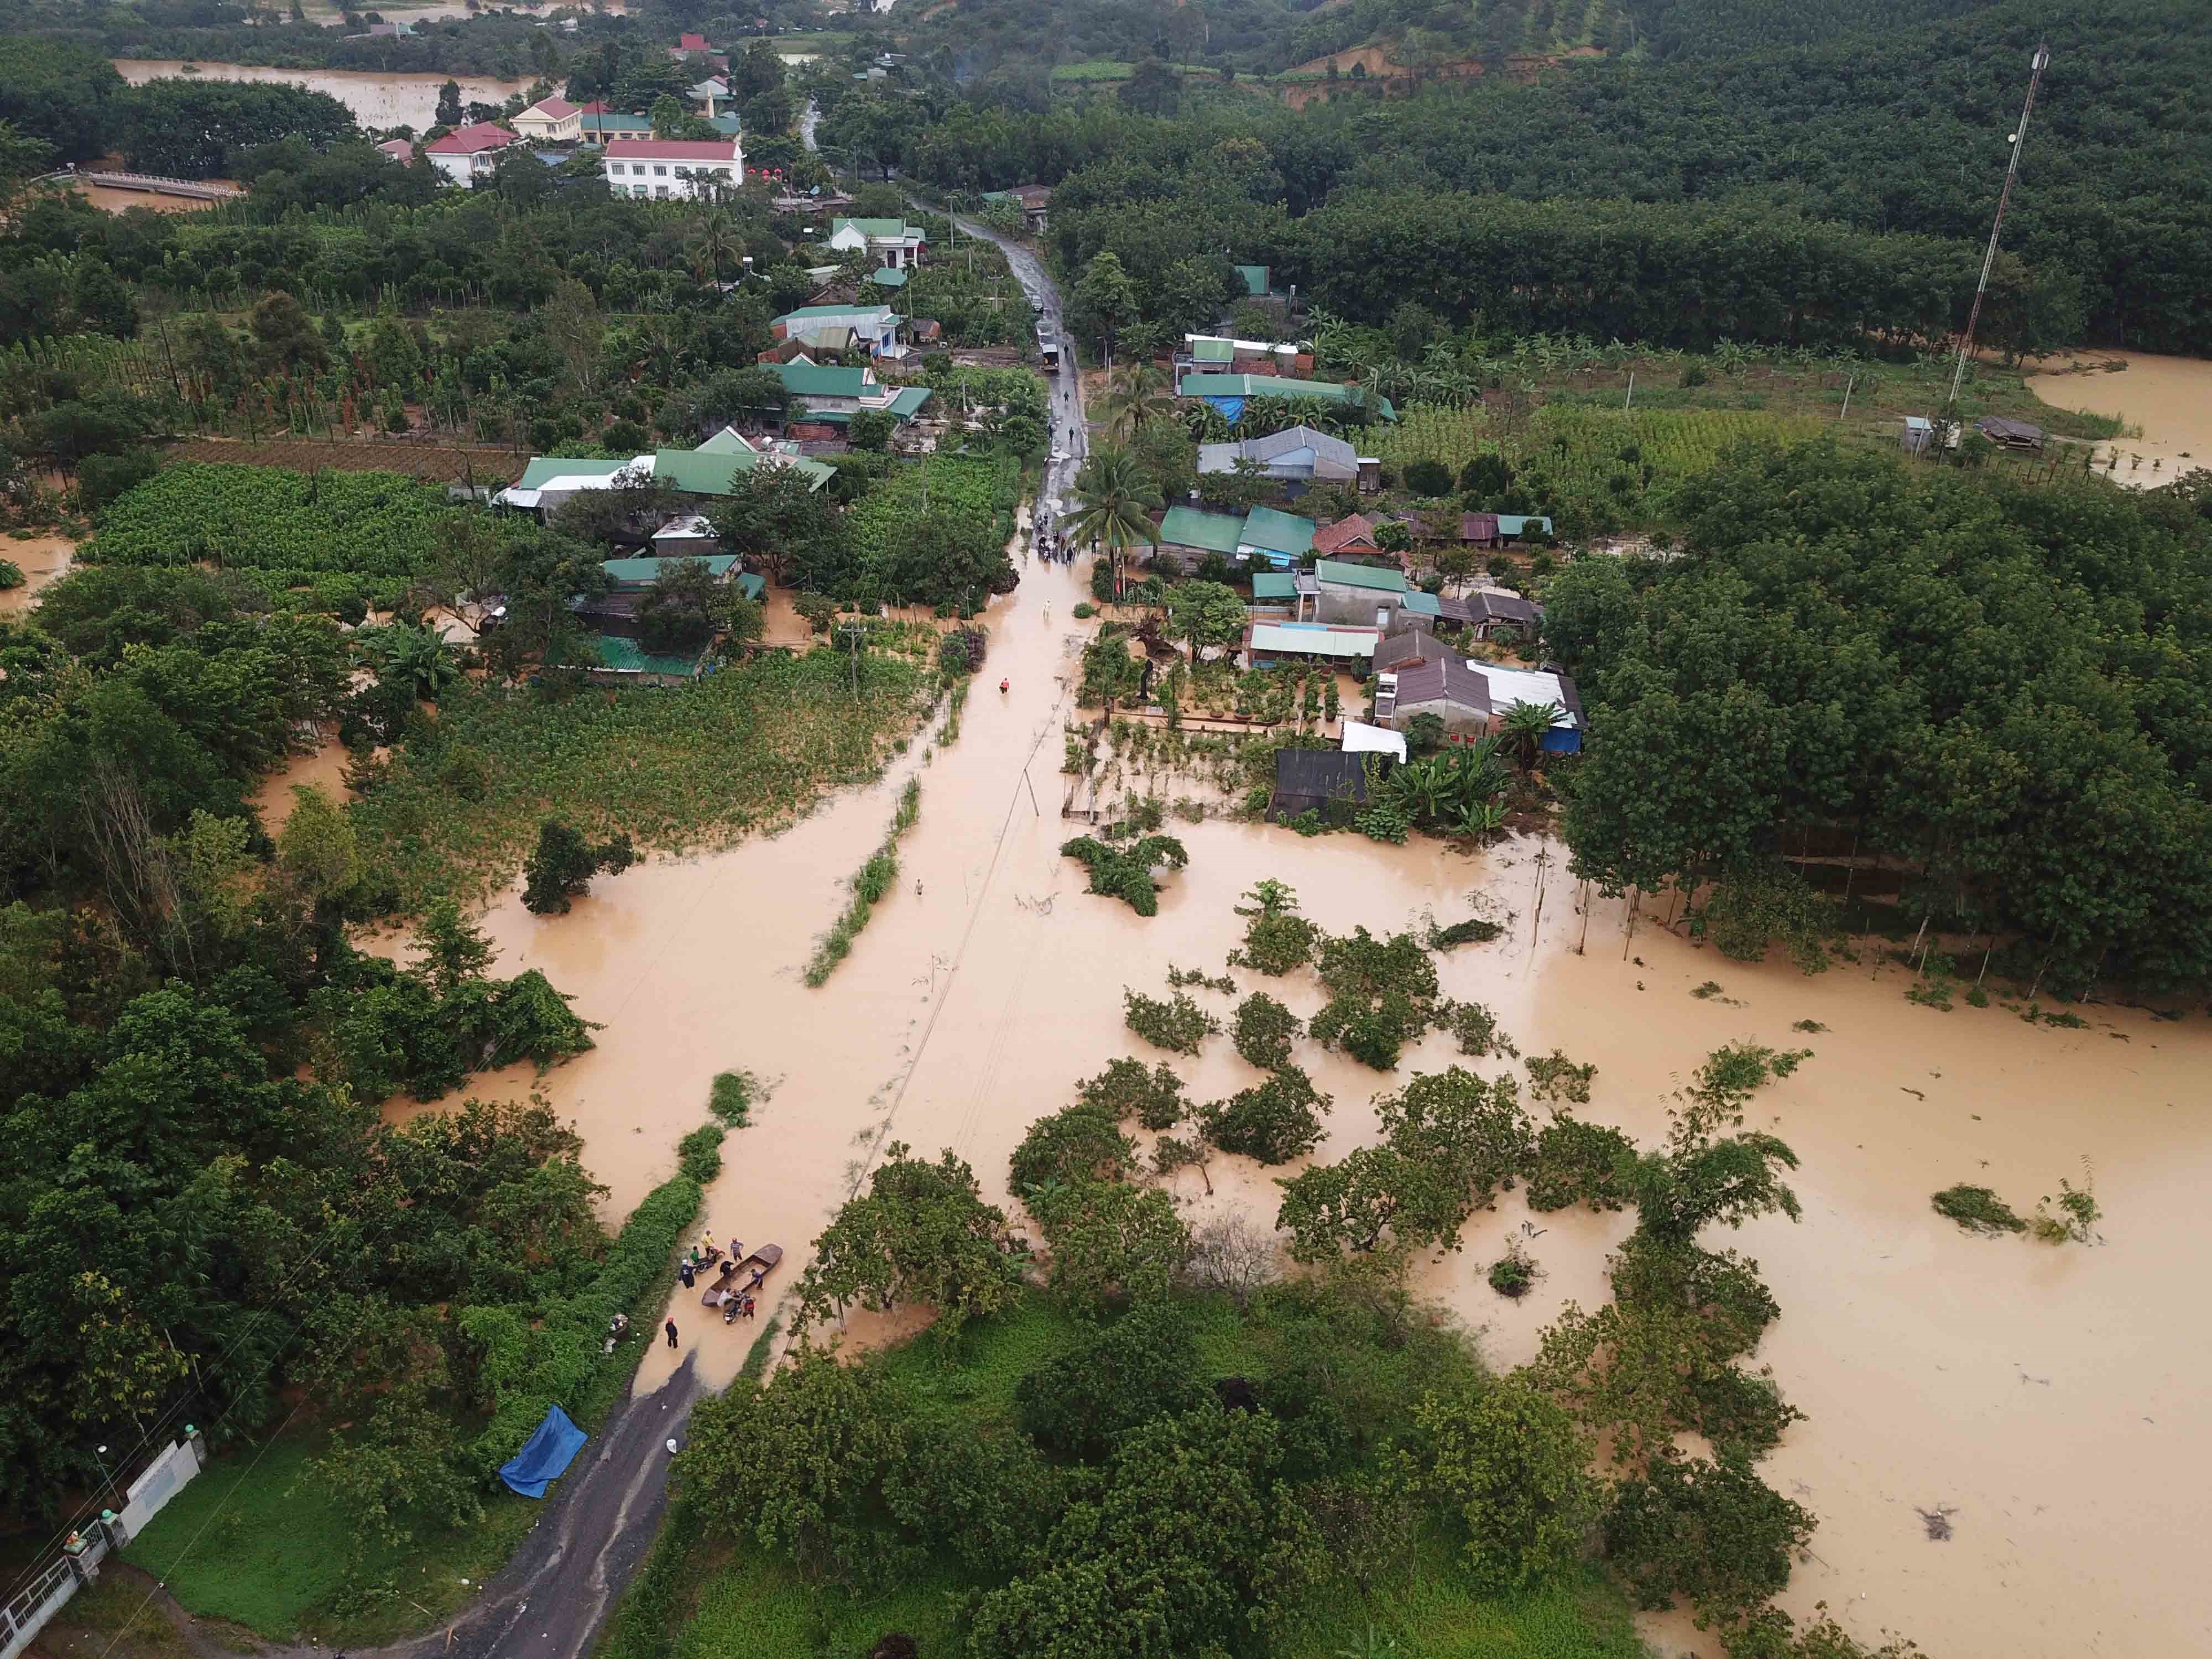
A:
124 1433 544 1646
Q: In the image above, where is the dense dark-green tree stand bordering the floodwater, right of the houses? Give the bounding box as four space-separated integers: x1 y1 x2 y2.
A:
1546 445 2212 995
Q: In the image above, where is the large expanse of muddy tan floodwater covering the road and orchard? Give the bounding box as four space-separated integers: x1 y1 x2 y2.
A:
398 553 2212 1657
